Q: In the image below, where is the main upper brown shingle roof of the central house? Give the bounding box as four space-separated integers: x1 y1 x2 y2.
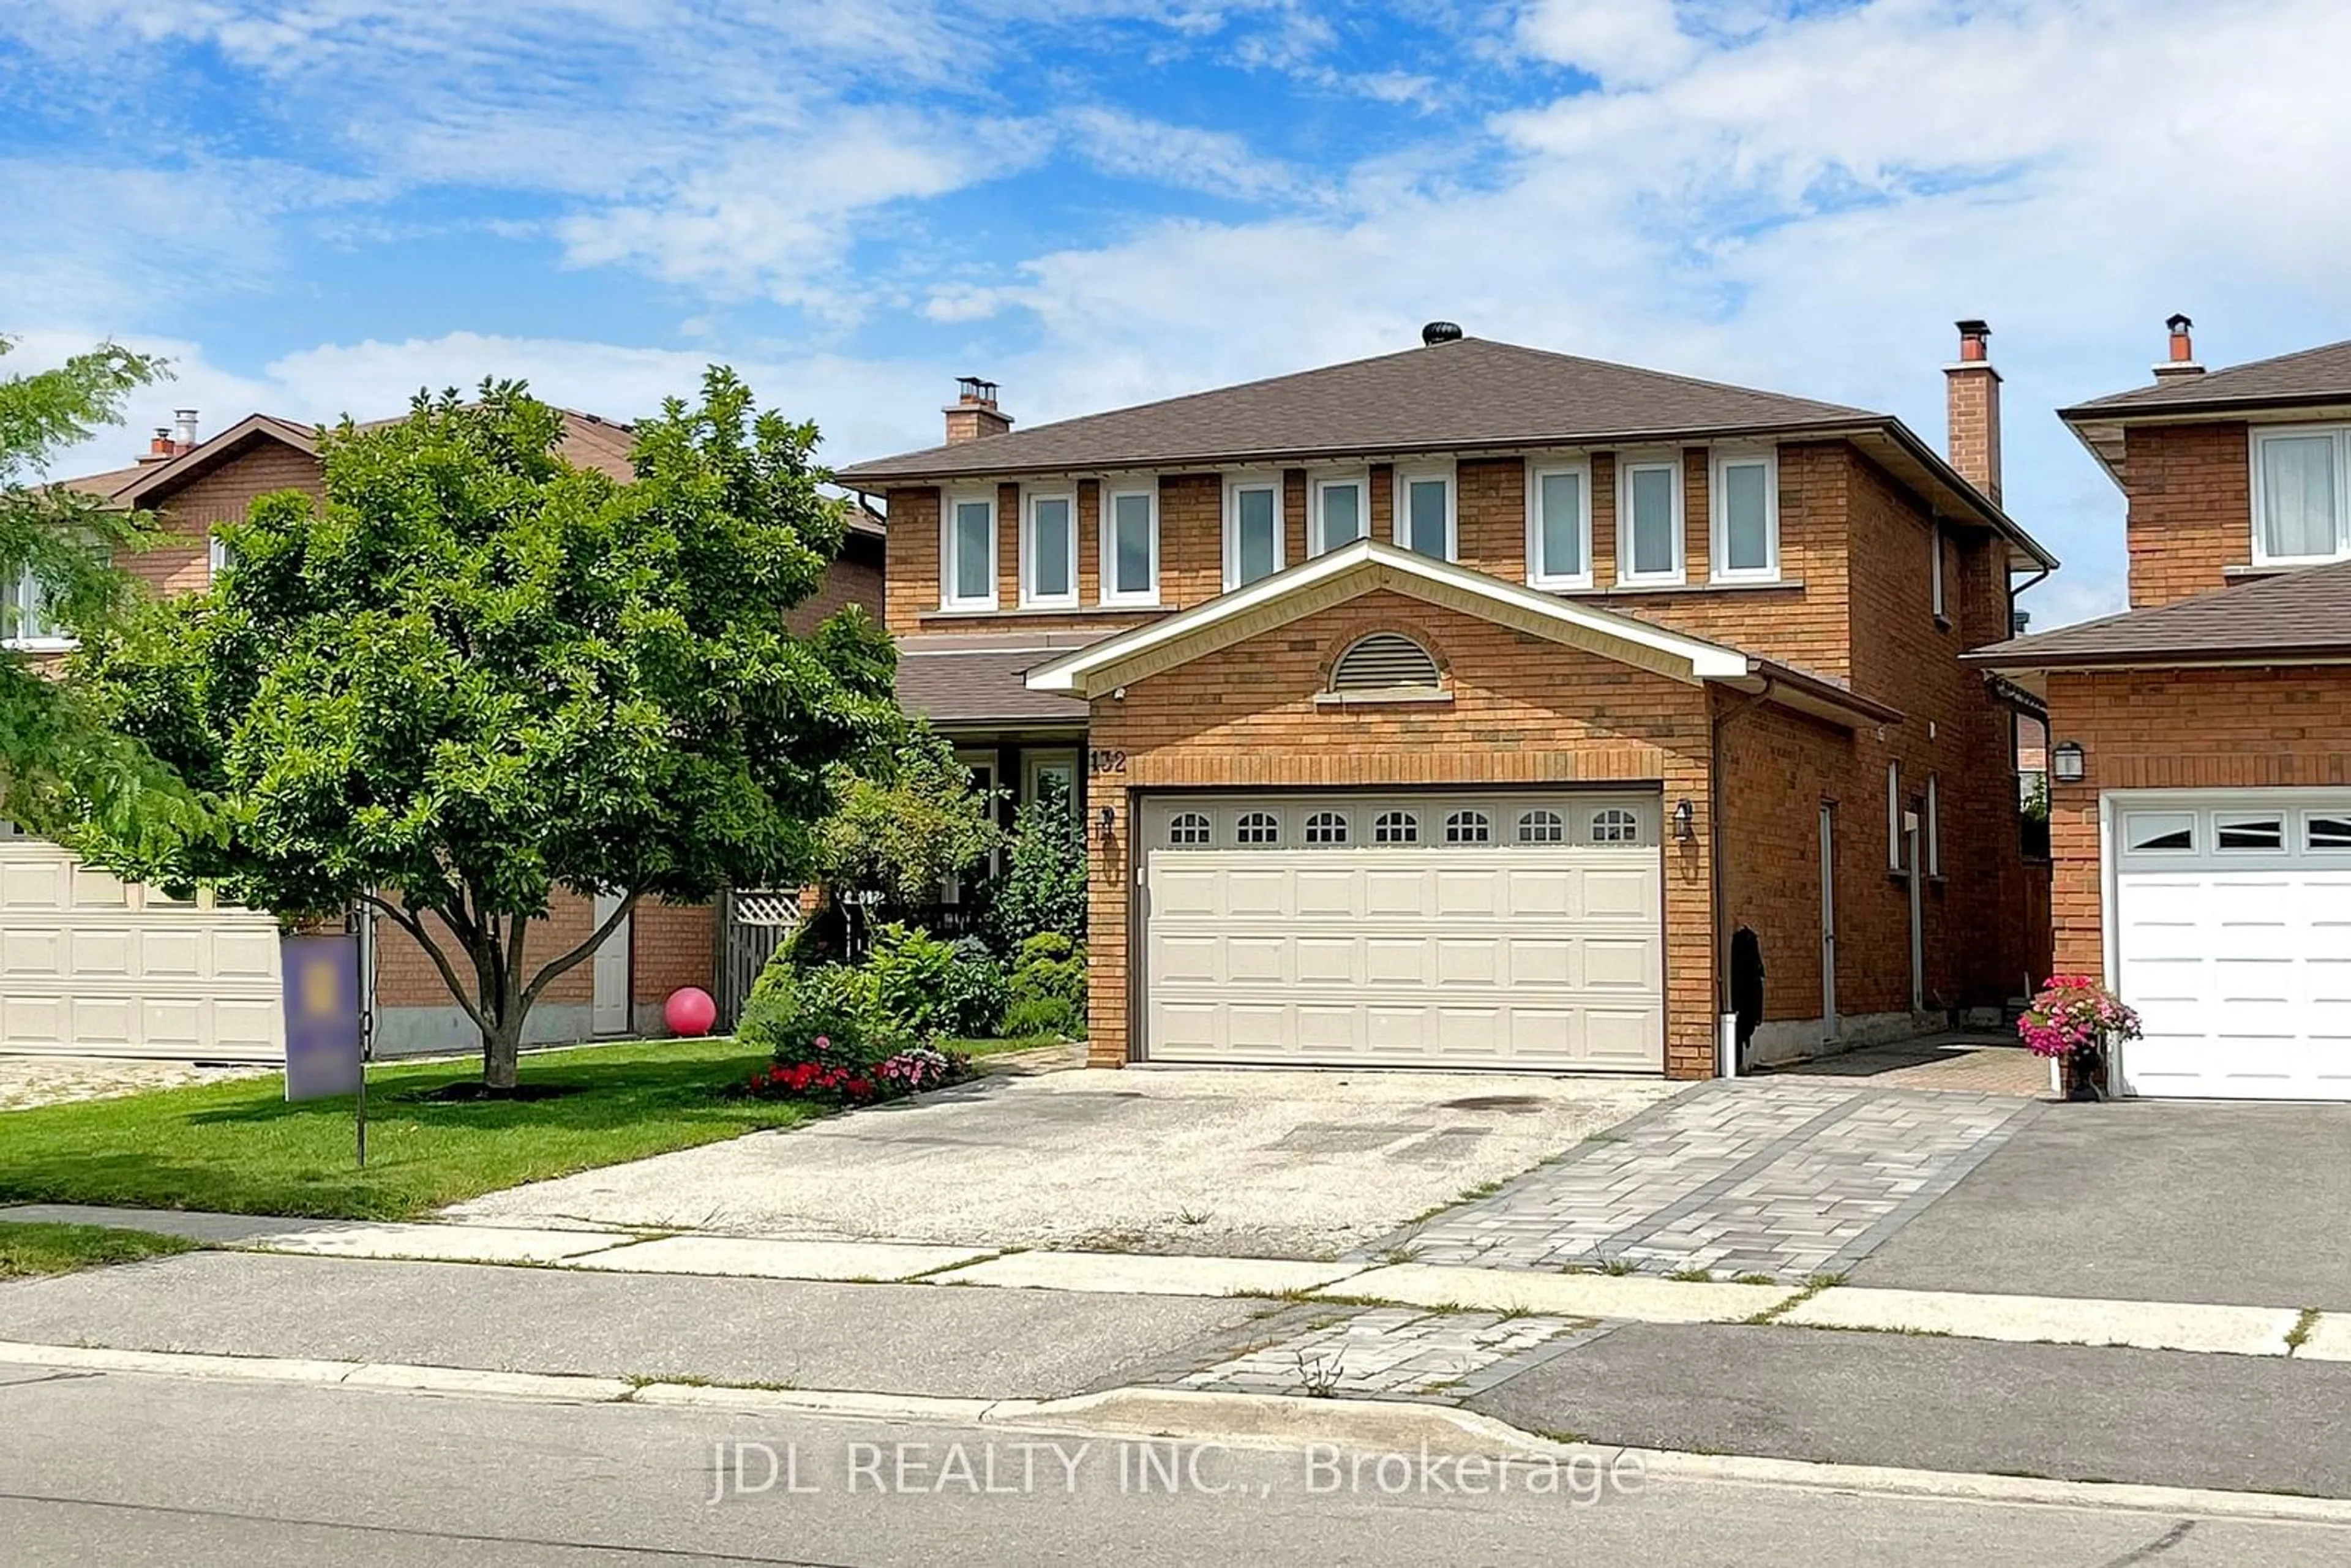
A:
839 339 1886 487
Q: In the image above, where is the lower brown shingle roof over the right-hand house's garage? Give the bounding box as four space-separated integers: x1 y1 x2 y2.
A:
1968 562 2351 670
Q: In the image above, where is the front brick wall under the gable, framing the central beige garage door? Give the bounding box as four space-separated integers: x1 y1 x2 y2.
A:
1089 593 1714 1077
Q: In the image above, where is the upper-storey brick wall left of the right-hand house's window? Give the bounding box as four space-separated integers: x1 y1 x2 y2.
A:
2123 423 2252 609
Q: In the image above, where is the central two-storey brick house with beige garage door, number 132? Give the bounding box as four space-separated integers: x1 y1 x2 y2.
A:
839 322 2055 1077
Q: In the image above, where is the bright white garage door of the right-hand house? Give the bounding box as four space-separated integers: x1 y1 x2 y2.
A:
2109 790 2351 1100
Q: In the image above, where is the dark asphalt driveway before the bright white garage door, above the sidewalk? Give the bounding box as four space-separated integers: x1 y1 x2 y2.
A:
1853 1100 2351 1310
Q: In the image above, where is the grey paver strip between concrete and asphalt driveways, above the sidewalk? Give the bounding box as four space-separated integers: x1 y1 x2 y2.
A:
1373 1079 2041 1279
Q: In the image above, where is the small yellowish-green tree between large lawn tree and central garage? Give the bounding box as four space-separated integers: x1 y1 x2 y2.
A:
816 731 1004 905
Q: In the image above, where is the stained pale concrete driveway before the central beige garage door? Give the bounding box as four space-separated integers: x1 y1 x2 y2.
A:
447 1067 1681 1258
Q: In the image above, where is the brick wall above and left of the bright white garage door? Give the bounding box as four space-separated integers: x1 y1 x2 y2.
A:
2050 666 2351 975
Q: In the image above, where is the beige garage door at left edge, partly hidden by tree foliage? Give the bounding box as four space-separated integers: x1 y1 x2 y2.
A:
0 825 285 1062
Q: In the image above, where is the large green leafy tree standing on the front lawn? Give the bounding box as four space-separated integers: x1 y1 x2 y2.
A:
82 369 903 1091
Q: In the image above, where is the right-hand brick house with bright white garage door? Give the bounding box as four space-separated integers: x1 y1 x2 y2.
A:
1973 315 2351 1100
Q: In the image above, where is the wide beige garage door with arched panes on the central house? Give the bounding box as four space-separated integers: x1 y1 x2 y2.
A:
1140 792 1665 1072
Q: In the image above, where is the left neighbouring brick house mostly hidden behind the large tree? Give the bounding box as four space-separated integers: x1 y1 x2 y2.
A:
0 411 884 1058
